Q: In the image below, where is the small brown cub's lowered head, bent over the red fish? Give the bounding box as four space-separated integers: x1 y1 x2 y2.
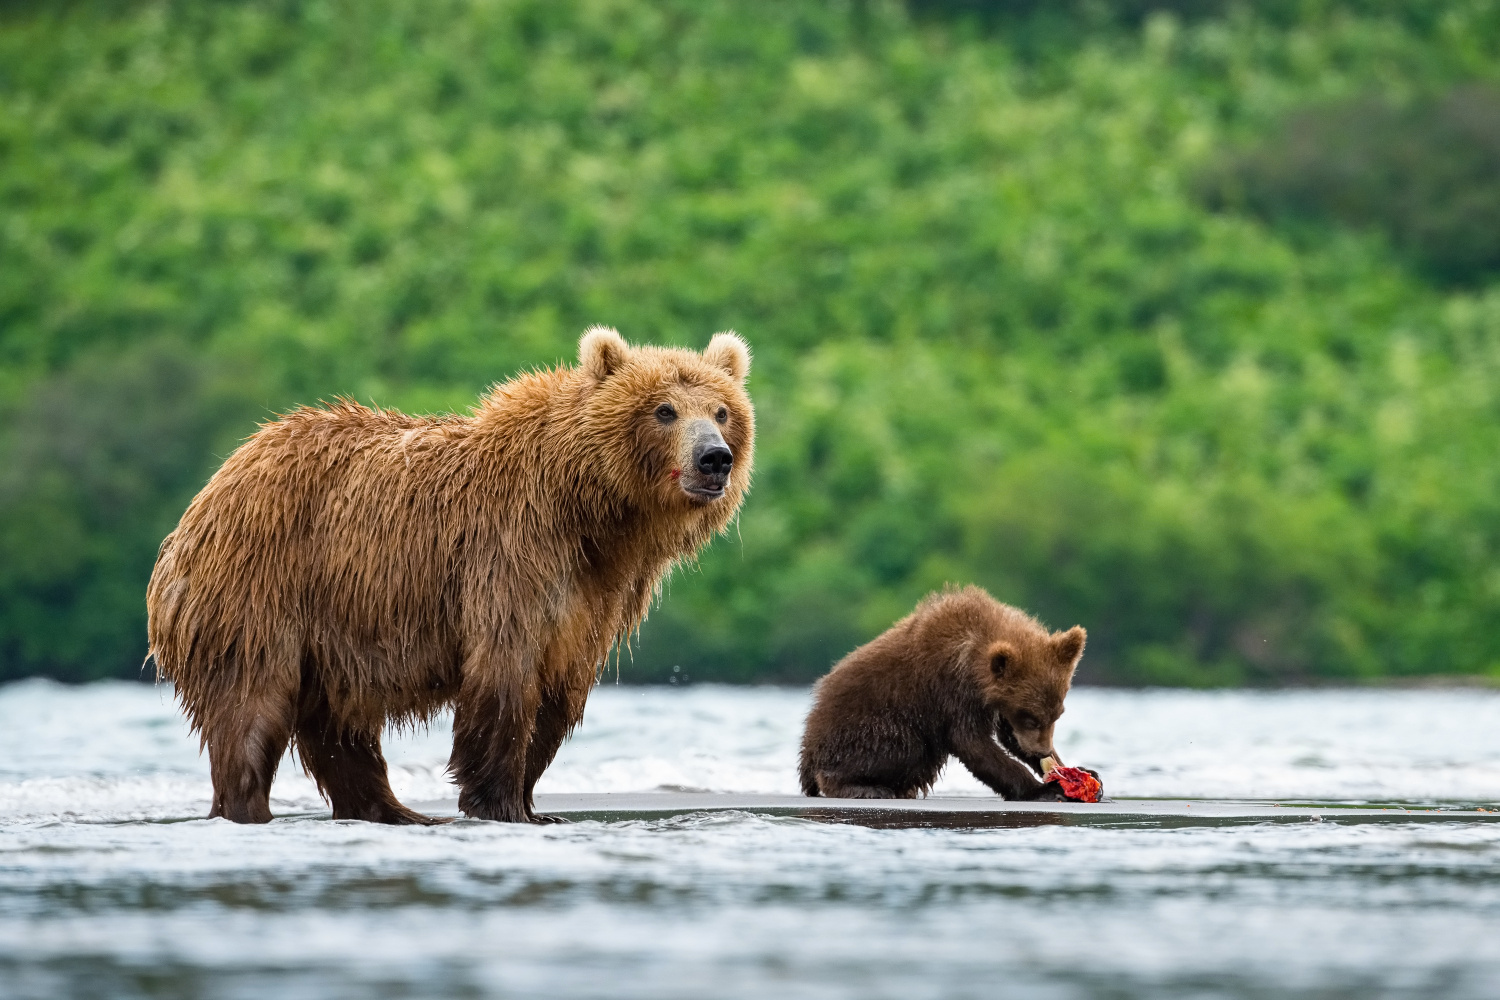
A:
980 618 1088 771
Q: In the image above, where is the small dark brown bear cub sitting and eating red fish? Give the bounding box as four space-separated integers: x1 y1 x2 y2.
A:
801 586 1085 799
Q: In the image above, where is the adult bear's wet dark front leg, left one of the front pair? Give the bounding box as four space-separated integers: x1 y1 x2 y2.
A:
449 675 540 823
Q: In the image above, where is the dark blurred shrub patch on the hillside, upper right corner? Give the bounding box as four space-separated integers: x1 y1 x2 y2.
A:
1202 85 1500 285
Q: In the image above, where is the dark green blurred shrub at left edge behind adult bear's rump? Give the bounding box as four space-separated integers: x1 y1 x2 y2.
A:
0 340 257 681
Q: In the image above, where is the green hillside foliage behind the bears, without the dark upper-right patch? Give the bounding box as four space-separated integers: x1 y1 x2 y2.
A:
0 0 1500 684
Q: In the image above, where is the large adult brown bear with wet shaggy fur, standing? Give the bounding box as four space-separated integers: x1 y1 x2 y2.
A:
147 327 755 823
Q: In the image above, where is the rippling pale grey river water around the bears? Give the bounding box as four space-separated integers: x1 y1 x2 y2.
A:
0 682 1500 999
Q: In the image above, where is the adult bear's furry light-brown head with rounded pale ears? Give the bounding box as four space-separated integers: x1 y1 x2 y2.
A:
578 327 755 528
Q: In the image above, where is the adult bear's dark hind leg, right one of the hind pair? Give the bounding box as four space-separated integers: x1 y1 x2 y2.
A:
297 691 443 826
